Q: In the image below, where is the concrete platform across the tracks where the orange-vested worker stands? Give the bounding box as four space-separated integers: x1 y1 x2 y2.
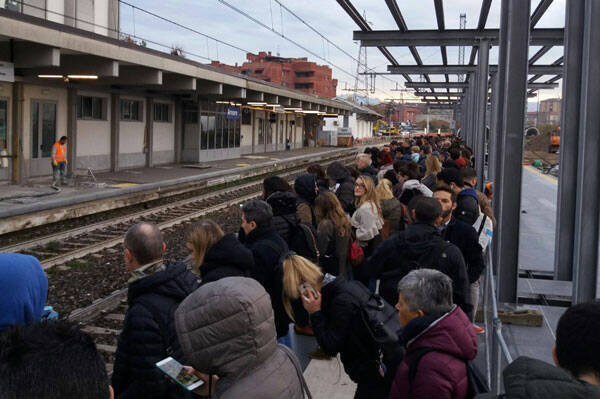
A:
0 147 353 218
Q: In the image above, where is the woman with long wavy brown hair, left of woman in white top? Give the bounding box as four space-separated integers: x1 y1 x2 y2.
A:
315 191 352 278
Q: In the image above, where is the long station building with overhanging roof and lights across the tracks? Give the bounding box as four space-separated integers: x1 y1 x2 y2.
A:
0 0 352 183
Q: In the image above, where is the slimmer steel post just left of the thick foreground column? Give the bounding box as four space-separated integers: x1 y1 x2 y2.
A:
473 40 490 191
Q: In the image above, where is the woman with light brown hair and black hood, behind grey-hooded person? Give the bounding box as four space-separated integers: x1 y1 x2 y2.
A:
185 219 254 285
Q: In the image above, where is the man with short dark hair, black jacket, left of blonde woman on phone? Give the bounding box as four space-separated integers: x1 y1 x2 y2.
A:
239 200 291 346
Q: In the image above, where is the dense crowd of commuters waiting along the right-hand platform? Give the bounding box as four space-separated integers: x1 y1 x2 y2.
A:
0 138 600 399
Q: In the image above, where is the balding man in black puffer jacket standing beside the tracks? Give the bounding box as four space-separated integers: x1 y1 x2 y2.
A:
112 223 198 399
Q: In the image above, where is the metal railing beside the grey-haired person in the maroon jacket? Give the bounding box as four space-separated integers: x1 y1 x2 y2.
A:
482 247 513 394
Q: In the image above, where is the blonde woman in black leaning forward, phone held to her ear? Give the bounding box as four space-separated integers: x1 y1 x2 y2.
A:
283 253 401 399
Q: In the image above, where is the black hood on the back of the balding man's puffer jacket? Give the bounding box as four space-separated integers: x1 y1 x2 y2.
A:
127 262 198 304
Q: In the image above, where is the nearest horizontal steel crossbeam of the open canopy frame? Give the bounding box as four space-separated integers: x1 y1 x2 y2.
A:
353 28 564 47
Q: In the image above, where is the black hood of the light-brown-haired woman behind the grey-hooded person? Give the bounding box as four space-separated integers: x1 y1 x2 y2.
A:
200 233 254 276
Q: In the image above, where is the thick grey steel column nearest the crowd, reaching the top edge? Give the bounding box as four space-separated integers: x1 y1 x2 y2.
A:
496 0 531 303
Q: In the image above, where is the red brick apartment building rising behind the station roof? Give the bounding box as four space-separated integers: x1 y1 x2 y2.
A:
210 51 337 98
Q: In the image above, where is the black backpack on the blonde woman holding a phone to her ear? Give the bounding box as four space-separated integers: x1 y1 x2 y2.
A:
346 280 404 377
